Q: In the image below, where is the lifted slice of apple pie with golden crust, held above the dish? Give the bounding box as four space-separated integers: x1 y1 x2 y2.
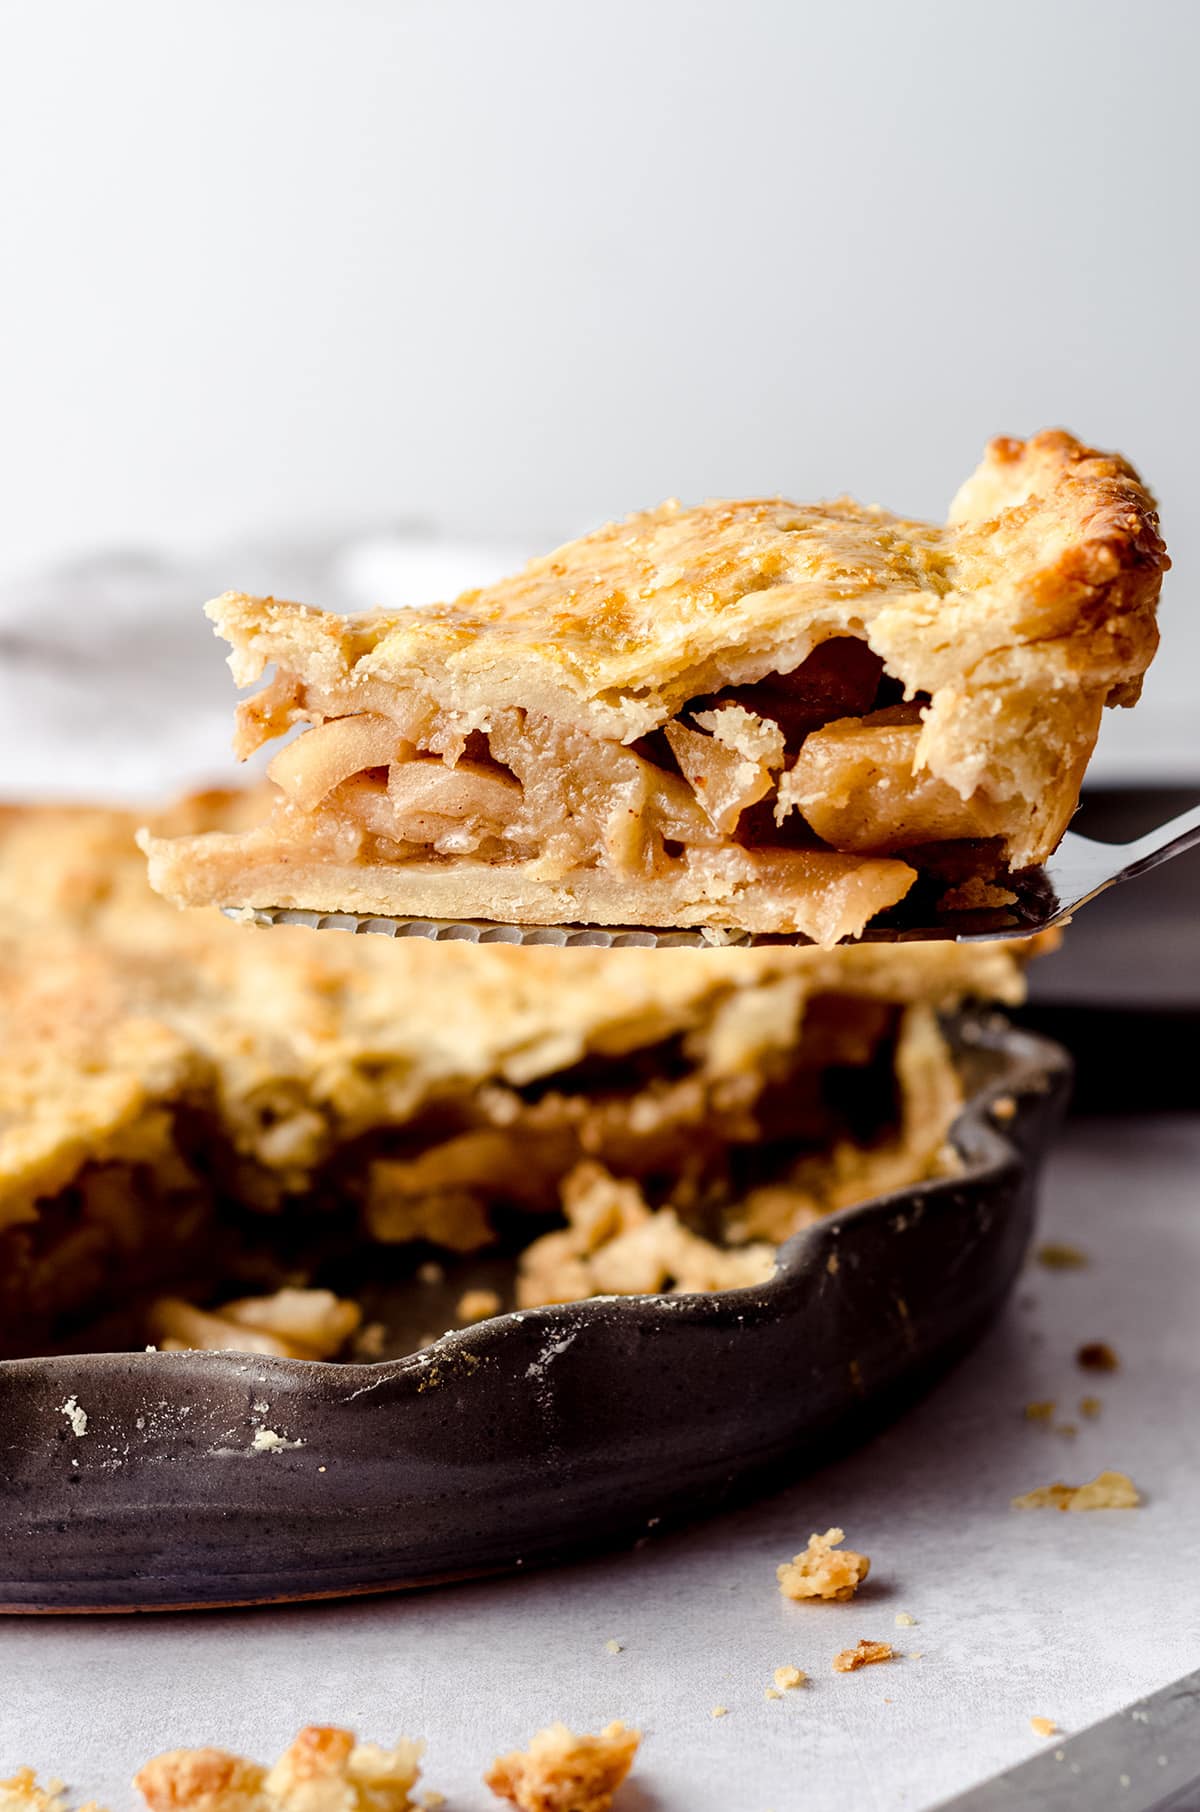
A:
143 431 1167 944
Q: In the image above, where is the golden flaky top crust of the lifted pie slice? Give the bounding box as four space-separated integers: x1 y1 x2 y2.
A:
208 429 1167 746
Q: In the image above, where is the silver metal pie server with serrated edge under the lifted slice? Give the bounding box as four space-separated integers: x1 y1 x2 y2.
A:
223 805 1200 949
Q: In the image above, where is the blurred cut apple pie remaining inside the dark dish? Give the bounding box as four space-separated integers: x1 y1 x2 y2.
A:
0 795 1044 1357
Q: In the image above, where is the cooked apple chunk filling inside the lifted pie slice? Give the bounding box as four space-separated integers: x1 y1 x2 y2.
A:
222 636 1008 942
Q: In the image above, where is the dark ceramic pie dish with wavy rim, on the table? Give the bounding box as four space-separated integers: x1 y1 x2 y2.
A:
0 1017 1069 1611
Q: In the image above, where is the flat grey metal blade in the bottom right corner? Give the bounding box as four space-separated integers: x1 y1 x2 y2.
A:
935 1672 1200 1812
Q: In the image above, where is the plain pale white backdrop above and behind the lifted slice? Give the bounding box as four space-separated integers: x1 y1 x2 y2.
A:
0 0 1200 770
